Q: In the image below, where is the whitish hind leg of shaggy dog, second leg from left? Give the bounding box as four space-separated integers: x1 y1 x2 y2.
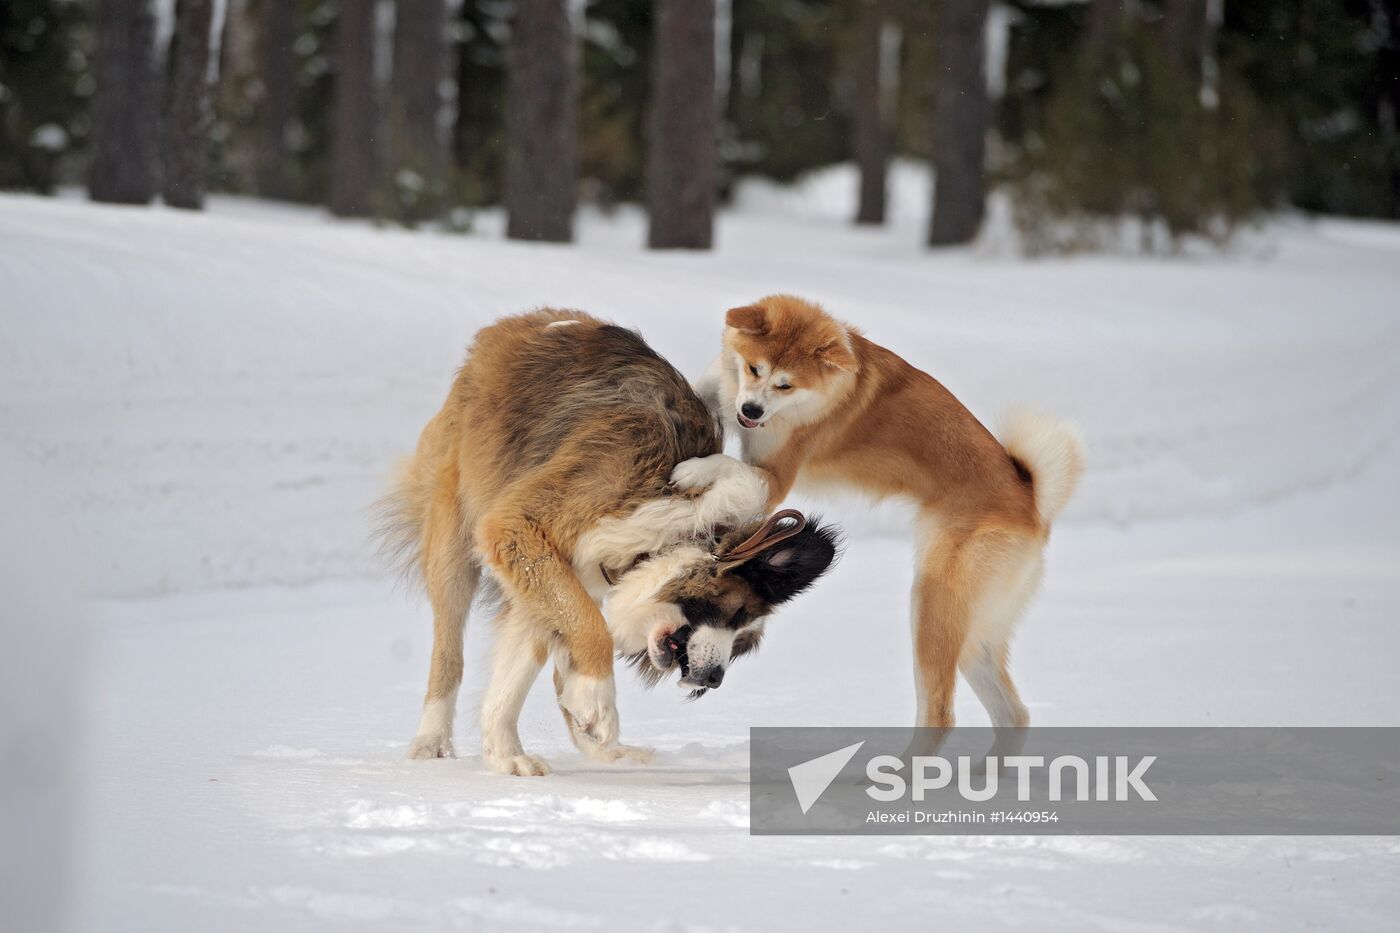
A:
482 604 549 778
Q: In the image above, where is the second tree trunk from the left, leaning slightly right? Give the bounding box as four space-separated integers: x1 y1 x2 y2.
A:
165 0 214 210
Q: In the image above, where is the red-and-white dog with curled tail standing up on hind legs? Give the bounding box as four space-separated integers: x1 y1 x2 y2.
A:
697 296 1084 728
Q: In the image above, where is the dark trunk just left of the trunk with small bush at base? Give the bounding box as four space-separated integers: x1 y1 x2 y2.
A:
331 0 377 217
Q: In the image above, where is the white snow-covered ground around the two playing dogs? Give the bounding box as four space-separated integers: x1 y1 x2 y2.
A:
0 174 1400 930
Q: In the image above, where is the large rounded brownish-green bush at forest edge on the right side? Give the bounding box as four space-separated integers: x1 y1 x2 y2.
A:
1009 12 1282 252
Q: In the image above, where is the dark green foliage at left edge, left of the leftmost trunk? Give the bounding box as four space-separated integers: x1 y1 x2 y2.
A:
0 0 95 193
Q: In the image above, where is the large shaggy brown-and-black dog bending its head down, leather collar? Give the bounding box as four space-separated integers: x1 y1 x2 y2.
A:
384 310 836 775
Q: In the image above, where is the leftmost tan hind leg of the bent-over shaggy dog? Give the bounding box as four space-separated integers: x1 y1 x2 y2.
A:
409 483 482 758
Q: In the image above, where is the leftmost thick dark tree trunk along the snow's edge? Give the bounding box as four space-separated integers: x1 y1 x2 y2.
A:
88 0 160 205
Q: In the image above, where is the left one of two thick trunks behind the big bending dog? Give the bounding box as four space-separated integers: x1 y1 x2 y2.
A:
505 0 578 242
